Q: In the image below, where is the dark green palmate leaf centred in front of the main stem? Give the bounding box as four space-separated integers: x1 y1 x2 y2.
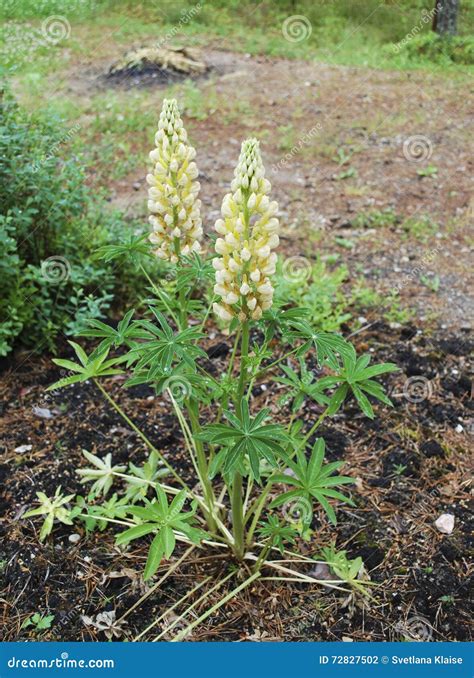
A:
198 400 287 481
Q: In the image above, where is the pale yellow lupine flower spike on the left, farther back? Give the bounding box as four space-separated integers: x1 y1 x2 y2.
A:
146 99 202 263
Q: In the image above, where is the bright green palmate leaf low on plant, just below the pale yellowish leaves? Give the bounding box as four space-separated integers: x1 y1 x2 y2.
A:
116 485 205 579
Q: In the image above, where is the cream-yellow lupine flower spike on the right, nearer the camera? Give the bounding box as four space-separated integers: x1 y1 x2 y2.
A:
213 139 279 322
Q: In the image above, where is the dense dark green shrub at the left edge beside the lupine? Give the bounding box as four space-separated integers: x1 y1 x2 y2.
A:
0 90 144 355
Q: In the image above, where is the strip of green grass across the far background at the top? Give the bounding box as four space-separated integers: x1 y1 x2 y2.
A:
0 0 474 75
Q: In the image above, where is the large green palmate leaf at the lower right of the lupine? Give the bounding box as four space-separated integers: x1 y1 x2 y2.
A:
270 438 354 525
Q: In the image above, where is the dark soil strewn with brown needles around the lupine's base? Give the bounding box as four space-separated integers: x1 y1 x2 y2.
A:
0 323 473 640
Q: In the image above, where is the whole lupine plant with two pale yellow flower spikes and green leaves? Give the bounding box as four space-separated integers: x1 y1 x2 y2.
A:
25 100 396 604
